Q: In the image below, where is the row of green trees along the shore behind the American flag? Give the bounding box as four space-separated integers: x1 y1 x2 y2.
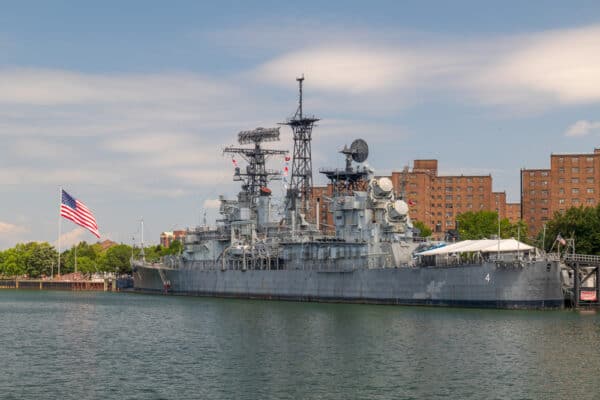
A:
0 240 182 278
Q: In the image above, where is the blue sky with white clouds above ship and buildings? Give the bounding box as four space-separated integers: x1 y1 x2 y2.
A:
0 0 600 249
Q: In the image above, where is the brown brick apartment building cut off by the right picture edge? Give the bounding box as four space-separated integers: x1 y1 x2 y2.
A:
521 149 600 235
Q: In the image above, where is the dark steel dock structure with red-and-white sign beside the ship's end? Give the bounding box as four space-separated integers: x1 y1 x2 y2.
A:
563 253 600 307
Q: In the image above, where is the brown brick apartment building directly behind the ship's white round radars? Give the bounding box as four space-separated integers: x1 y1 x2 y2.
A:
309 160 521 237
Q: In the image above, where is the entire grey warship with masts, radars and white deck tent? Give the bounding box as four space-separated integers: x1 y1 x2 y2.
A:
132 77 564 308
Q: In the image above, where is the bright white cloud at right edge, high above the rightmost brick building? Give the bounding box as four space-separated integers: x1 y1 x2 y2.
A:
472 26 600 104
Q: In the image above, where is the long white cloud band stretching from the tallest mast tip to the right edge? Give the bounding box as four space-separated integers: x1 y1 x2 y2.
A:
254 25 600 109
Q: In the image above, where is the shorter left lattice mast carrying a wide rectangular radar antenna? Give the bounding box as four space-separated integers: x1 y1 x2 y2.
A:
223 128 287 203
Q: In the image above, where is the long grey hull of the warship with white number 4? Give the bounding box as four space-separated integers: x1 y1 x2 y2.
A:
134 261 564 308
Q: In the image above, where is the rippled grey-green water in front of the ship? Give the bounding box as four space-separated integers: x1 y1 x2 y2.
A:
0 290 600 399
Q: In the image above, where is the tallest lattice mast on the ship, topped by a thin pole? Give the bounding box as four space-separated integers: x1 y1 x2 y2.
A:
283 75 319 215
